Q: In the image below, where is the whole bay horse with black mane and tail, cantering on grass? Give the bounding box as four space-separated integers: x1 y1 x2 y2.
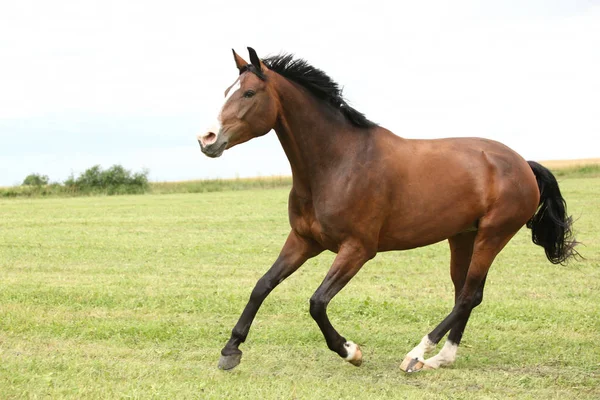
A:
198 48 577 372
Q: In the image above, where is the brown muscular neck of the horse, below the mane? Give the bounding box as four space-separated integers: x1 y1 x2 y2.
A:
275 81 365 197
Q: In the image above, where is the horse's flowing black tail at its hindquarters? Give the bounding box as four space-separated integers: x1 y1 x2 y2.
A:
527 161 579 264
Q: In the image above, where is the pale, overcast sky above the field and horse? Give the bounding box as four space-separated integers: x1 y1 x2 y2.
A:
0 0 600 186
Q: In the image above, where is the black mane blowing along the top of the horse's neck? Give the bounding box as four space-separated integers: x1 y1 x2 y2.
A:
262 54 377 128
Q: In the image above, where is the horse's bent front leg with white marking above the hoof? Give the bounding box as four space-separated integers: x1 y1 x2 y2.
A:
310 243 375 367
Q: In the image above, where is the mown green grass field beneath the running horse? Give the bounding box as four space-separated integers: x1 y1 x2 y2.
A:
0 178 600 399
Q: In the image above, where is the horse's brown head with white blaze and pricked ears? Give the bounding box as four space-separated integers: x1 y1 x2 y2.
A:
198 47 278 157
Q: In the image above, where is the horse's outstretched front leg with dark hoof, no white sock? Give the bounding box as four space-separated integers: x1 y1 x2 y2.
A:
219 231 323 369
